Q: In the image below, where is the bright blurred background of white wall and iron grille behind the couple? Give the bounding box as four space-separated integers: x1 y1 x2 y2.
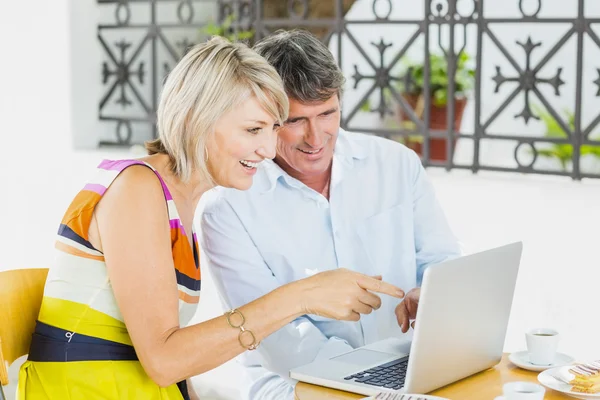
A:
0 0 600 399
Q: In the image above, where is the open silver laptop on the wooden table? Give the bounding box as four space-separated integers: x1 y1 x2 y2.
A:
290 242 523 396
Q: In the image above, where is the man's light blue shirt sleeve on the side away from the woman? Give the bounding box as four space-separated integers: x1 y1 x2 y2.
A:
412 153 461 286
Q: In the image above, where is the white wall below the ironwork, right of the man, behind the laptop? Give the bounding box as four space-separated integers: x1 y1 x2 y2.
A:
429 170 600 359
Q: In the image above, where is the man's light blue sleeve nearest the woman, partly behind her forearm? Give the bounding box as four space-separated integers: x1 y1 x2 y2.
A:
202 199 352 399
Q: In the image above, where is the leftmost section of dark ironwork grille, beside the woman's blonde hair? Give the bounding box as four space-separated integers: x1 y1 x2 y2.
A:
97 0 247 146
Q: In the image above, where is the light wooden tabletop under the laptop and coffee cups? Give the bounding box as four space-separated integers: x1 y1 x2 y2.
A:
296 354 573 400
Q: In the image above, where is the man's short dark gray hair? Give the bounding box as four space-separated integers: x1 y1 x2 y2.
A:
254 29 346 104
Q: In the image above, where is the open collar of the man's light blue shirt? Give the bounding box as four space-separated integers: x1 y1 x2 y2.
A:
261 128 368 194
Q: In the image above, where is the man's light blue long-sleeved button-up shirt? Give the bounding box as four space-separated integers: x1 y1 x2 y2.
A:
202 131 460 400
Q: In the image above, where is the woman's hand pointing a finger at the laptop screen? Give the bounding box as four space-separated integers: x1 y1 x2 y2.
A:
298 268 404 321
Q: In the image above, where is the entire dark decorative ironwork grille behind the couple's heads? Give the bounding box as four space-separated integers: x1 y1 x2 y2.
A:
97 0 600 180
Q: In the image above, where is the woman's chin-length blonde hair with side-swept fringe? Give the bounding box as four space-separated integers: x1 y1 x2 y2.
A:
146 37 289 184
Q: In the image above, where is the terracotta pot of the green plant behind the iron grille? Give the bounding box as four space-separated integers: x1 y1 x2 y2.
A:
398 93 467 162
